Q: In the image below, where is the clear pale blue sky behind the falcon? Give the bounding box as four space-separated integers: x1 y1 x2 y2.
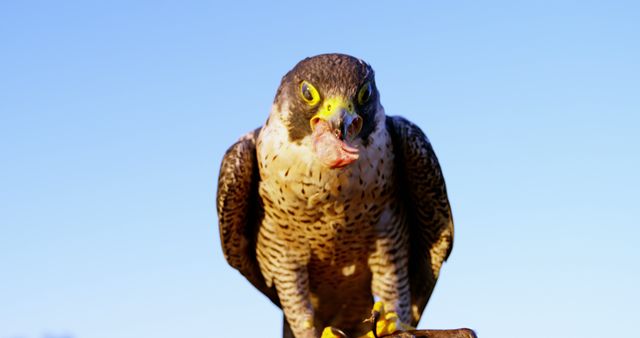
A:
0 0 640 338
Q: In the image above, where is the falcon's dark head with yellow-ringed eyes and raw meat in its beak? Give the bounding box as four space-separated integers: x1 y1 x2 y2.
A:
274 54 379 168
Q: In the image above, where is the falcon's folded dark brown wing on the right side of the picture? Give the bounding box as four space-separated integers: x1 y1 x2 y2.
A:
386 116 453 326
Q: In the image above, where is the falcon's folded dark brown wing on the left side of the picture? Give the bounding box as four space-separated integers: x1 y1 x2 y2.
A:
217 128 280 306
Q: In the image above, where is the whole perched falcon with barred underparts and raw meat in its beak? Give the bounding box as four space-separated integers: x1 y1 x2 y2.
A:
217 54 453 338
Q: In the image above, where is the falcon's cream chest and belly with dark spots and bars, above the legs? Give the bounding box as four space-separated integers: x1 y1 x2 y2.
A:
257 107 395 266
